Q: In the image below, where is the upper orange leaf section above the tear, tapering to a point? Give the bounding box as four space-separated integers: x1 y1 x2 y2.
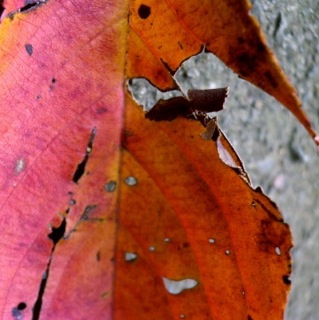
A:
126 0 319 143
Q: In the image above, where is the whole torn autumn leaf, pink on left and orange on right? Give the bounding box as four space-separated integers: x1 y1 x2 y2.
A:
0 0 315 320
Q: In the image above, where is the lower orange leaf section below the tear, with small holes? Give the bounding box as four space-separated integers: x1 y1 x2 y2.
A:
115 94 292 320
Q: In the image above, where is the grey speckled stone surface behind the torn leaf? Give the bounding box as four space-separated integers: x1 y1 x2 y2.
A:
131 0 319 320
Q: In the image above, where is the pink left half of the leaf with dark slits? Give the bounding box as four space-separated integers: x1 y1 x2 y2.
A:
0 0 128 319
